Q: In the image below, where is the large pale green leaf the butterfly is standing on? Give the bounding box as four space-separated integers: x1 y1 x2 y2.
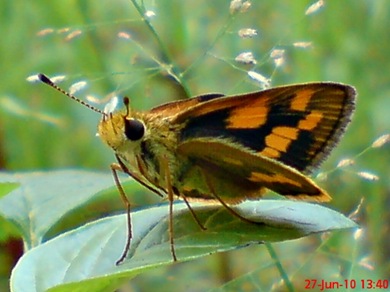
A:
11 200 356 292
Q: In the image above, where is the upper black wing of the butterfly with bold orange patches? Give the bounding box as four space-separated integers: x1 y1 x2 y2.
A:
172 83 356 173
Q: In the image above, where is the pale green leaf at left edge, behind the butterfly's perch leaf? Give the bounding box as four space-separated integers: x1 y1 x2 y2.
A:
0 170 118 249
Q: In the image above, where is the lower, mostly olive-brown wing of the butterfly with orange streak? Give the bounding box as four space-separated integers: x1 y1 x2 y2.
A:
177 138 331 204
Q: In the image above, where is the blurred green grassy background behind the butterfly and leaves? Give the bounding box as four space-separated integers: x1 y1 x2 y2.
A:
0 0 390 291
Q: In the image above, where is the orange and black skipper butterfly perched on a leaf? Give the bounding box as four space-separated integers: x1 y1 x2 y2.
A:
39 74 356 264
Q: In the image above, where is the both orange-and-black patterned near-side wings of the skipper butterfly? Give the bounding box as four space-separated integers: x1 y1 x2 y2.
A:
172 83 356 203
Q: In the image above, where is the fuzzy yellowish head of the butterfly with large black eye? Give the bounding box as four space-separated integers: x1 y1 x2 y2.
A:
98 97 145 151
